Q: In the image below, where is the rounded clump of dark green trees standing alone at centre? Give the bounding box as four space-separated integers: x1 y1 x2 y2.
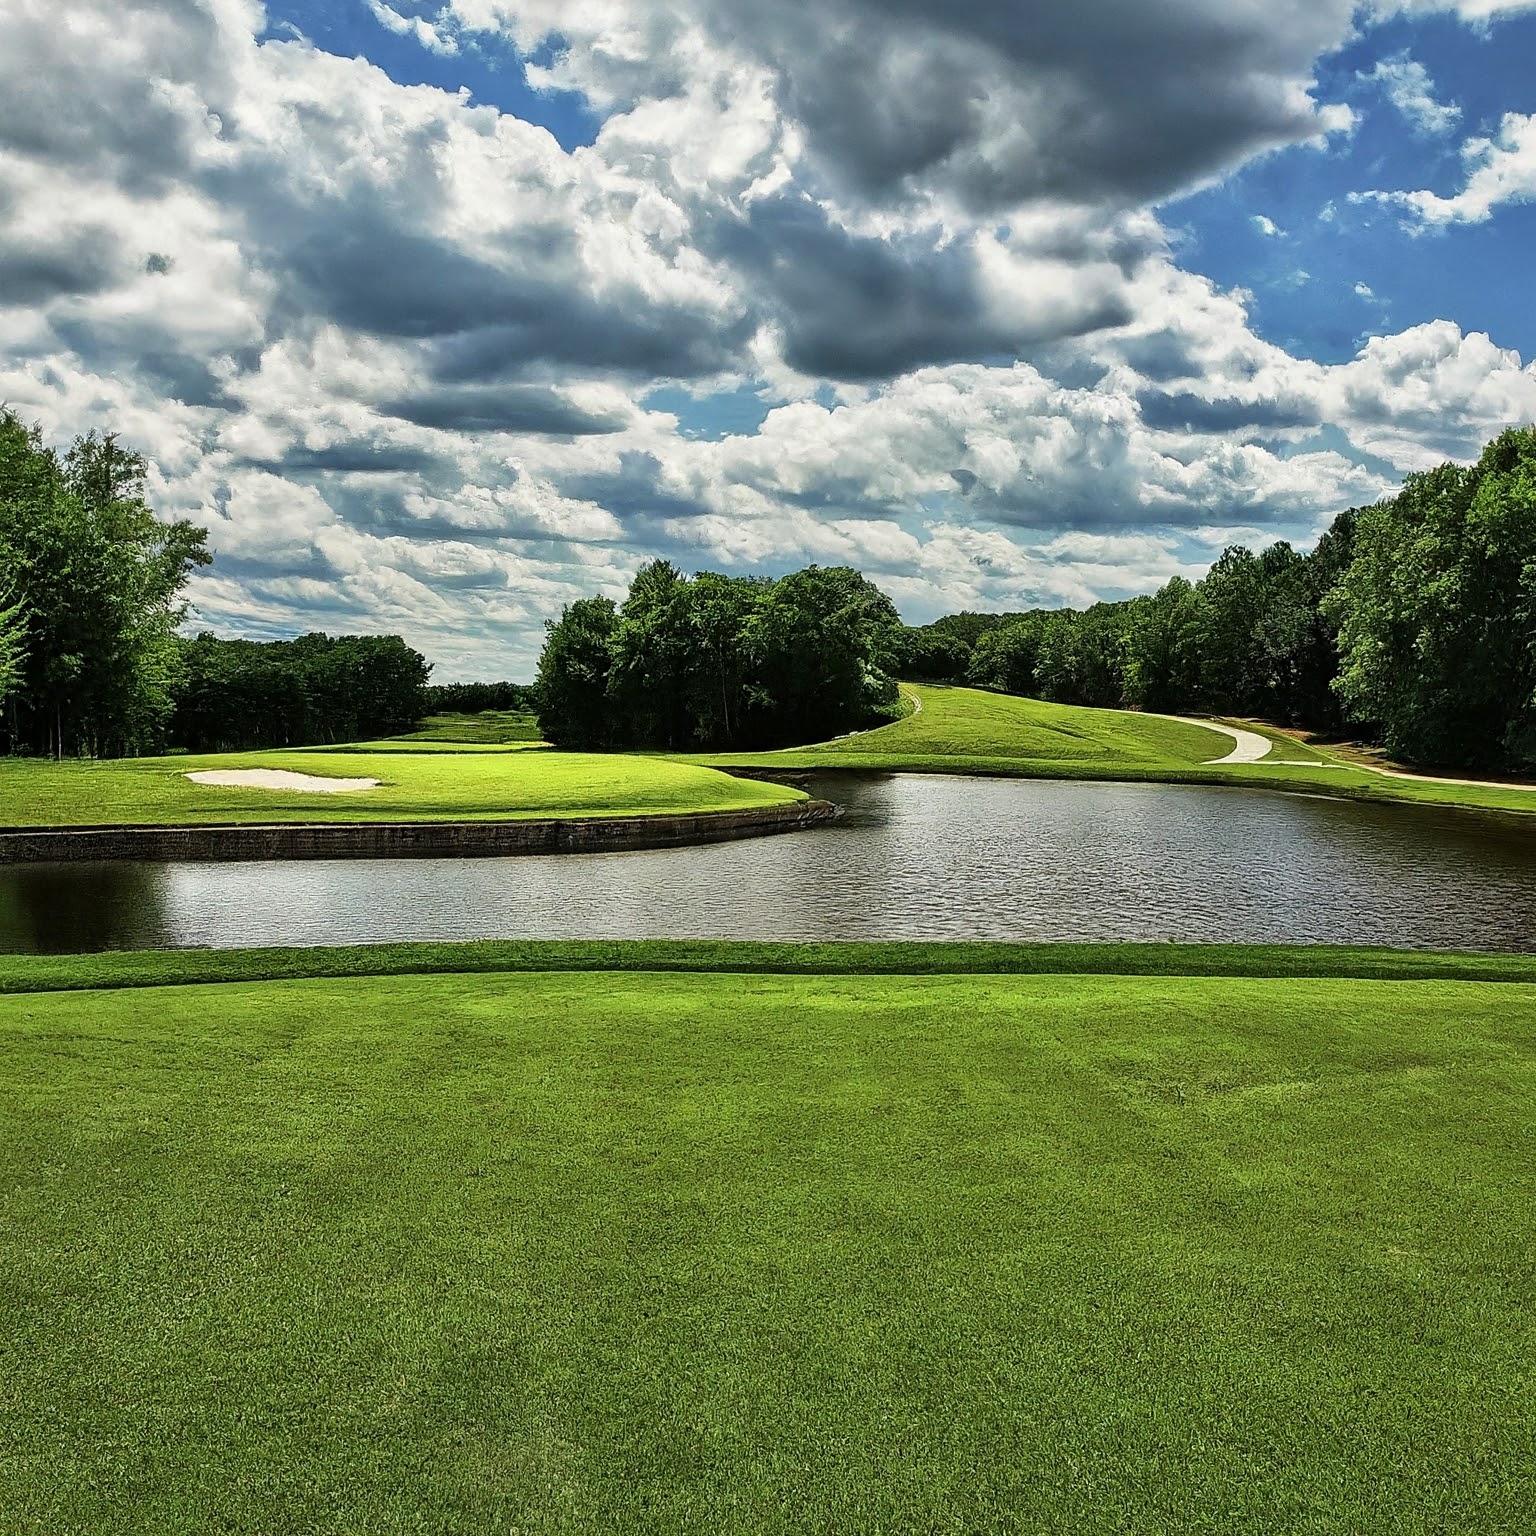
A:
533 561 900 750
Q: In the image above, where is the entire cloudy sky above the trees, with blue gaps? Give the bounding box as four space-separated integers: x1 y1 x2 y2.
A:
0 0 1536 680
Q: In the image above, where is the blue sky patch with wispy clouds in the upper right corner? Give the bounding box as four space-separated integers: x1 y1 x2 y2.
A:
1166 14 1536 362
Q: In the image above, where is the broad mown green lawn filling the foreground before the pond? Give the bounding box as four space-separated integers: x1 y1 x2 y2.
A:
0 946 1536 1536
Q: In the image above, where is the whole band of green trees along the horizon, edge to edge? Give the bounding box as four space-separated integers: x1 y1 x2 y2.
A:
0 410 1536 771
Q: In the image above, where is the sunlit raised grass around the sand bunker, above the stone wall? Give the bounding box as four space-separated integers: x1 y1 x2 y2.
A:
0 742 803 826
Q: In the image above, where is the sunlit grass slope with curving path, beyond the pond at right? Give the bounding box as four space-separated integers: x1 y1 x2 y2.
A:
687 684 1536 816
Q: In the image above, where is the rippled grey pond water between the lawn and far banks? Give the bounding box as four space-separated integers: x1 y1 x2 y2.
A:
0 774 1536 952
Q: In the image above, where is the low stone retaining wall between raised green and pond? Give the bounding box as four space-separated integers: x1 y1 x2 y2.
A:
0 800 839 863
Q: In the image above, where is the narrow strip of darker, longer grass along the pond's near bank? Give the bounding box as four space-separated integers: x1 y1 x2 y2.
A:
0 940 1536 994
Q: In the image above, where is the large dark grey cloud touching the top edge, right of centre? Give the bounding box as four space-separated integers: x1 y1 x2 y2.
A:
694 0 1353 207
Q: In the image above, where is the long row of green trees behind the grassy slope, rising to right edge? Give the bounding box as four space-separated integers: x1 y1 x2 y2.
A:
895 429 1536 771
